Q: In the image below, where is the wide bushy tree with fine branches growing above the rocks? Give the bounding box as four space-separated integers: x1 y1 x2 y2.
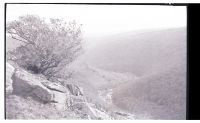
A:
6 15 82 79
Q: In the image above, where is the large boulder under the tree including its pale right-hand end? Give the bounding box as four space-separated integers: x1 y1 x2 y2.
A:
12 70 69 110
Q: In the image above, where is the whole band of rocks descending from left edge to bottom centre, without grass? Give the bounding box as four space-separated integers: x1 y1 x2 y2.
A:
6 63 135 120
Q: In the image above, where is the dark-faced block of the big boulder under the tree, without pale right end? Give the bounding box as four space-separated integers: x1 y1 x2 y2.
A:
12 70 53 103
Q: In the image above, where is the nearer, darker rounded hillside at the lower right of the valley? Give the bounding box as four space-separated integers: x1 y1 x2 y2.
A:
113 65 186 119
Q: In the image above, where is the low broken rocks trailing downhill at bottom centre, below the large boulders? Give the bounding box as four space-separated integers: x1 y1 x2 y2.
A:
67 96 135 120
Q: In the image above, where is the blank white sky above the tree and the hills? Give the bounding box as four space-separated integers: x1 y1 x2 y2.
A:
6 4 187 36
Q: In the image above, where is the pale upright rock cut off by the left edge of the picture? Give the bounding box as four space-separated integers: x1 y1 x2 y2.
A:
6 63 15 94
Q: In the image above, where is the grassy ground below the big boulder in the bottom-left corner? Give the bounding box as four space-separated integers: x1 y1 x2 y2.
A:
6 95 81 119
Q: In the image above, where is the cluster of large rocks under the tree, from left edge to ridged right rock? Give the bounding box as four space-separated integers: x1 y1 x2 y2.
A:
6 64 85 110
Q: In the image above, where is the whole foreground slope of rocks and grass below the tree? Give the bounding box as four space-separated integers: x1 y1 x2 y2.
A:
6 64 135 120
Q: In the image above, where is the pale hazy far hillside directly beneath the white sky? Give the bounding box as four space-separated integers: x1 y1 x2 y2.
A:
86 28 186 76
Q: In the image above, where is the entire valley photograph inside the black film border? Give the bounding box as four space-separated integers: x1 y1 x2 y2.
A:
6 4 187 120
